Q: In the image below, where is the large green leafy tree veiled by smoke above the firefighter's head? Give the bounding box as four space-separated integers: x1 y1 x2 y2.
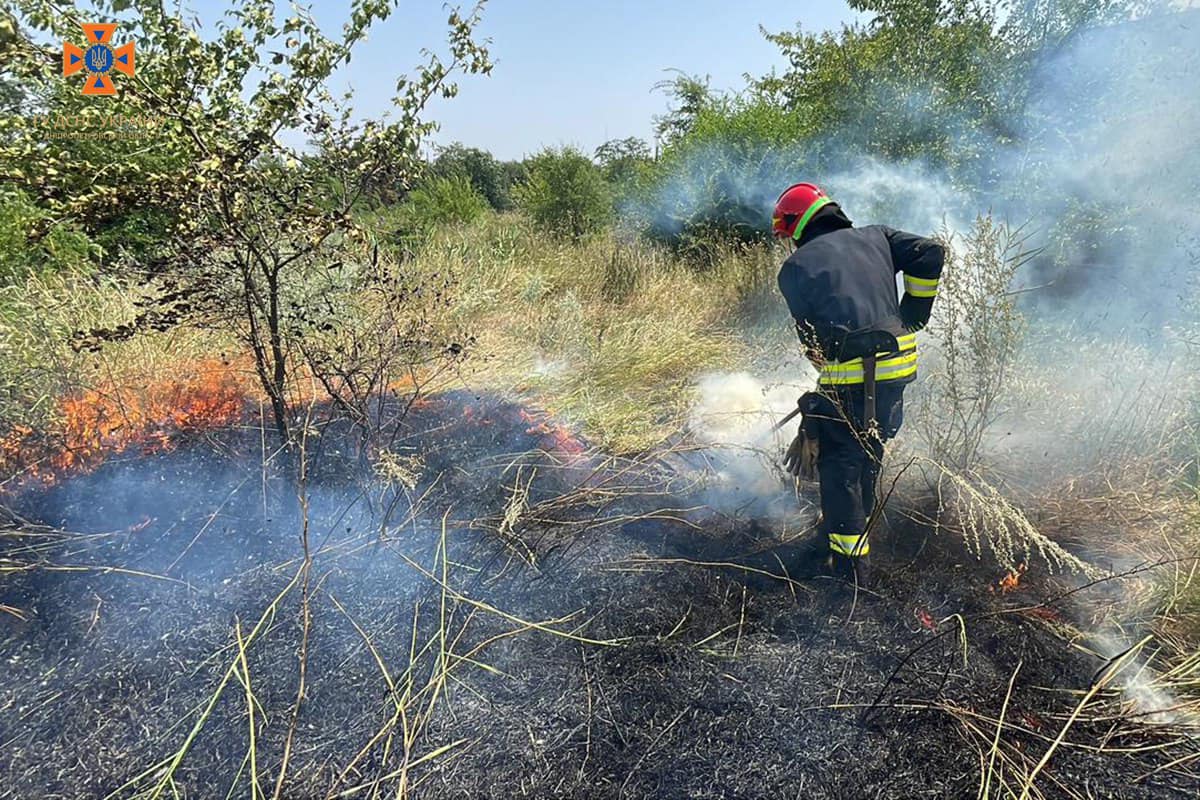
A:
632 0 1154 260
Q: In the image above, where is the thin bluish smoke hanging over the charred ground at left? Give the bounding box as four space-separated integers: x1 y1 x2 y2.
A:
0 392 667 796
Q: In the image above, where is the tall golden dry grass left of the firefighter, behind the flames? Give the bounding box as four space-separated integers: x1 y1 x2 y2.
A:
0 216 763 462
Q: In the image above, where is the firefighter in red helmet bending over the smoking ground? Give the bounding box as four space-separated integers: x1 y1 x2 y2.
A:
772 184 946 583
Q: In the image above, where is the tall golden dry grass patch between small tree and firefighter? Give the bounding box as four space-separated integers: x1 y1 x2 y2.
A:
403 217 775 452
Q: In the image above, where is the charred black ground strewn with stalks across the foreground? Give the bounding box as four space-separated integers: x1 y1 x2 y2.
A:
0 395 1200 799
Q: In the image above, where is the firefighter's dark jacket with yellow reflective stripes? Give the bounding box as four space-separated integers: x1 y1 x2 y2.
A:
779 221 946 386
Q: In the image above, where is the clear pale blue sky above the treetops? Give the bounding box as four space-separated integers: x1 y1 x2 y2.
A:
187 0 853 158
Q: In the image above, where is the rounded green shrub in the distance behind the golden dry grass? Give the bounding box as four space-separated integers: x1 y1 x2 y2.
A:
514 148 613 239
